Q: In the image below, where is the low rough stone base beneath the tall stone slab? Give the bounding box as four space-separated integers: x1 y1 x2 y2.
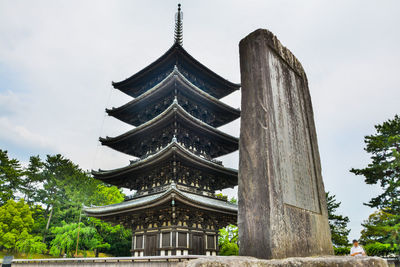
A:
178 256 388 267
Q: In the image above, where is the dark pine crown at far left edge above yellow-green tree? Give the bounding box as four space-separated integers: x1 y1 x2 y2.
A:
0 149 23 205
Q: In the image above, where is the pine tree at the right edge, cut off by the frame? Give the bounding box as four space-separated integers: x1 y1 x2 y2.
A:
350 115 400 251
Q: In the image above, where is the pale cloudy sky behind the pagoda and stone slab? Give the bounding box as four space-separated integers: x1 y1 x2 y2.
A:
0 0 400 243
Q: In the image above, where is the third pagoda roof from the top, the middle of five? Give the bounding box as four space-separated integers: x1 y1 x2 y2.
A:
100 100 239 158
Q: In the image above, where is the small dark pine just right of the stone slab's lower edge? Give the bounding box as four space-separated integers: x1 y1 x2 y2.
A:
325 192 350 247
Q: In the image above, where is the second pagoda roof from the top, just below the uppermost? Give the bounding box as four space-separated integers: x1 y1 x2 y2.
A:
106 67 240 127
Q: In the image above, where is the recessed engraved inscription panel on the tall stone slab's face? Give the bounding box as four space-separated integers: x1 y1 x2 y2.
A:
269 53 320 213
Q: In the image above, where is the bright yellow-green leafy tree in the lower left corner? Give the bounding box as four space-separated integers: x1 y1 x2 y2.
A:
0 199 46 253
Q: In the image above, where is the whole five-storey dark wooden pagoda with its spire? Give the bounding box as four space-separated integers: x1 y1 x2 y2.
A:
84 5 240 257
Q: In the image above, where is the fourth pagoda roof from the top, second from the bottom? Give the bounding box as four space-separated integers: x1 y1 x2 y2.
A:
92 138 238 190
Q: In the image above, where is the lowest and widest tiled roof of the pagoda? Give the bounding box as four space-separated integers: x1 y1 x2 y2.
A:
83 184 238 220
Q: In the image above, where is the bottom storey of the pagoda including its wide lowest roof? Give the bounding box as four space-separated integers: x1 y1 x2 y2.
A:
86 183 237 257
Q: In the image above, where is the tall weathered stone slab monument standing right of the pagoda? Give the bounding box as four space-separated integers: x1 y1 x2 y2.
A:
238 30 333 259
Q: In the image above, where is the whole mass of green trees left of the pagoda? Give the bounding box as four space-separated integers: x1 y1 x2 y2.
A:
0 150 131 256
